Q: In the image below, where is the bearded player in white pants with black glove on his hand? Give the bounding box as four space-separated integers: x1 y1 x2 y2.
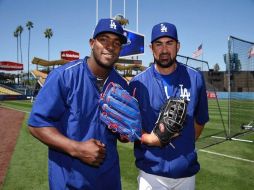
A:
130 22 209 190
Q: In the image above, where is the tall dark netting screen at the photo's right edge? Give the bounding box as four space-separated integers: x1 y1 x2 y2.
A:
224 36 254 138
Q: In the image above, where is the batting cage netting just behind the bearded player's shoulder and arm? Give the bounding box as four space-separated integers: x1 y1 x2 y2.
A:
177 55 227 148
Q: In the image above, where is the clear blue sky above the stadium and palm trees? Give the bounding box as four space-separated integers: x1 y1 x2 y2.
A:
0 0 254 70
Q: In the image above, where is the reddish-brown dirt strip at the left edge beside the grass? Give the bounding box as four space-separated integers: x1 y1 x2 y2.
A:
0 107 25 188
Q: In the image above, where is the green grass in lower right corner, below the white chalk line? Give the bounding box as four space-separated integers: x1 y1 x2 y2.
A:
196 148 254 190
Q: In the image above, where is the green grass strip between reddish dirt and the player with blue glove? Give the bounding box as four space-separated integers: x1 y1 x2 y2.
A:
3 114 48 190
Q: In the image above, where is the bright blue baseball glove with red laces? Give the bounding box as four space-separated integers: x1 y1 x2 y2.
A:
100 82 141 142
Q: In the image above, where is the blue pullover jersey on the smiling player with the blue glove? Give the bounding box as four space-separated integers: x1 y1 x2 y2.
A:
28 58 128 190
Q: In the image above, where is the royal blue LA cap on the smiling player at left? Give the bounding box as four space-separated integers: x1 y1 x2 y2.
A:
93 18 127 44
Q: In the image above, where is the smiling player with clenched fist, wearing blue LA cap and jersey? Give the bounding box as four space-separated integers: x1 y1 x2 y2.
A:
28 19 128 190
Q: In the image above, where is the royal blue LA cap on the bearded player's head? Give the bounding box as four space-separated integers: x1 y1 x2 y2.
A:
151 22 178 43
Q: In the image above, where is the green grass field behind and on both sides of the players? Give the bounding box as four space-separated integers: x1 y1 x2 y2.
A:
0 100 254 190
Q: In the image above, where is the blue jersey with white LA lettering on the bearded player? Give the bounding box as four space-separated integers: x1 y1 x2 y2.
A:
130 62 209 178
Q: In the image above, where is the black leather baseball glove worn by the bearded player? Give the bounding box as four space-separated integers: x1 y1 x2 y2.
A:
153 98 187 146
